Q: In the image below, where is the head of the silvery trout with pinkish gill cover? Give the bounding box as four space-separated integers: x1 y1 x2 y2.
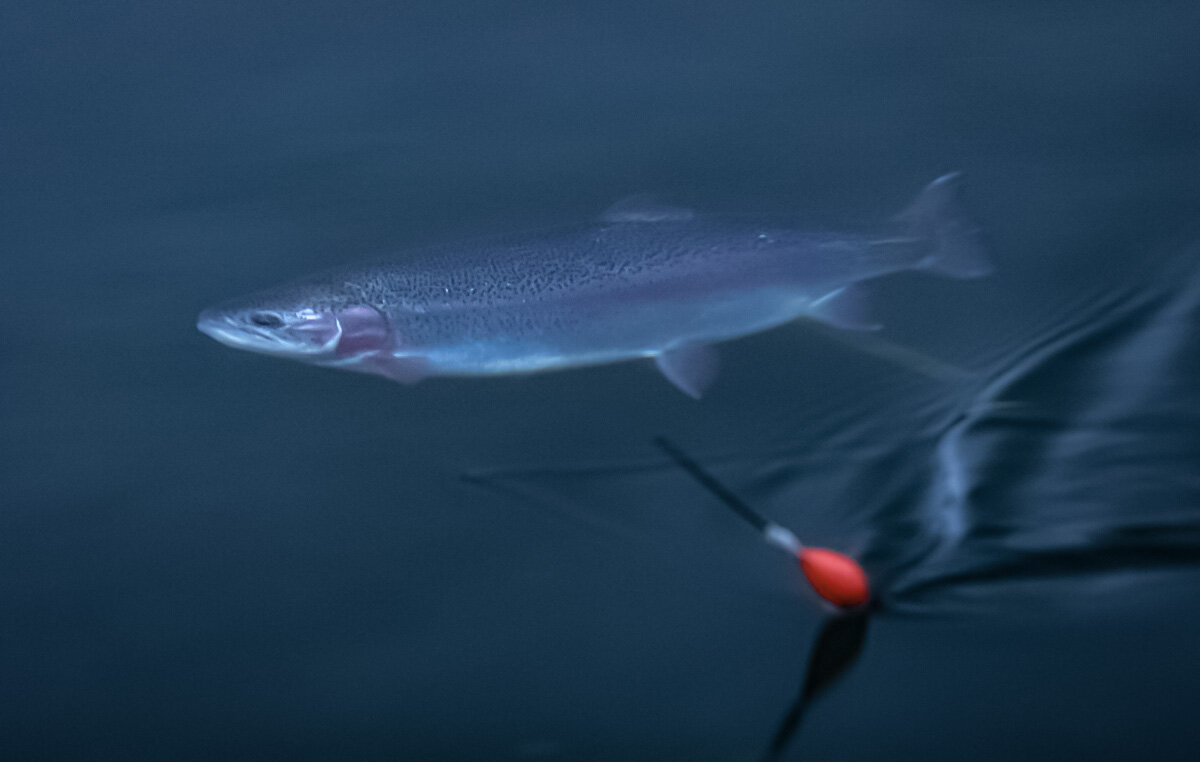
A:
196 290 391 364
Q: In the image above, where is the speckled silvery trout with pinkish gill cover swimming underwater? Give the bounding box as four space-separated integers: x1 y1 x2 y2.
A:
197 173 992 398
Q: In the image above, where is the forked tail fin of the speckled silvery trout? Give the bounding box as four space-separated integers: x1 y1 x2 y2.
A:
896 172 992 278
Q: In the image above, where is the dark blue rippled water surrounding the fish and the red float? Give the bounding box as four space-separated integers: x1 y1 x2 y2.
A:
7 2 1200 760
